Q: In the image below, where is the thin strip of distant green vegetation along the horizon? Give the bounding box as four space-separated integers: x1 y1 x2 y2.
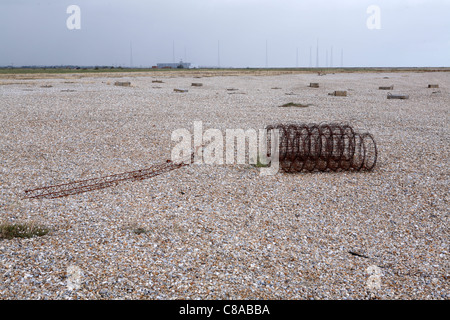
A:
0 66 450 74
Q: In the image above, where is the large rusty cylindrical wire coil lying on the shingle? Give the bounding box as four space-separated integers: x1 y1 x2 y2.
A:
266 123 377 173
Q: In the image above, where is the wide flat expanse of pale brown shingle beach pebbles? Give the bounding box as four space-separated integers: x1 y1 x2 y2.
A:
0 71 450 299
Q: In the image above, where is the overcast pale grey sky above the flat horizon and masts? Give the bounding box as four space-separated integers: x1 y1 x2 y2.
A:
0 0 450 67
